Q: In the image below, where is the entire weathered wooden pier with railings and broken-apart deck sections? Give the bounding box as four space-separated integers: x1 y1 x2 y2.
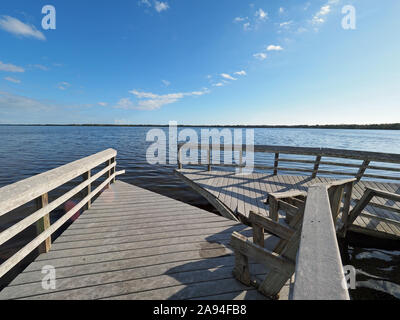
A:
0 146 400 300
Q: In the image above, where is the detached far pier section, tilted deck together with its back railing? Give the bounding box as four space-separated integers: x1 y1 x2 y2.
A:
175 144 400 240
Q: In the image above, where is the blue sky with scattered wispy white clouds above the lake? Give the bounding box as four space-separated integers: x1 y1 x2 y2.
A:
0 0 400 124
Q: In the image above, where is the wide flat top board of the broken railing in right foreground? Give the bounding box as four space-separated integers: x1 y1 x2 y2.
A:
293 184 349 300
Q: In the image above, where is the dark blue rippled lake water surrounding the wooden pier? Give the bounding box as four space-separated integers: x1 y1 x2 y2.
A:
0 126 400 299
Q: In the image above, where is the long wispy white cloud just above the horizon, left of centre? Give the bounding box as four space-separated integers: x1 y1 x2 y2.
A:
114 88 209 110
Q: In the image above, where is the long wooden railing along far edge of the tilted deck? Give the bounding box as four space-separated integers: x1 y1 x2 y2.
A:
178 143 400 180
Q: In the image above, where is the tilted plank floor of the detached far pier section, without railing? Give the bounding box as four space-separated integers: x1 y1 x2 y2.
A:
175 168 400 239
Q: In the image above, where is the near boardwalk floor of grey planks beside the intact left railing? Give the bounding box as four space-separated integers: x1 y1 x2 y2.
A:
0 181 290 299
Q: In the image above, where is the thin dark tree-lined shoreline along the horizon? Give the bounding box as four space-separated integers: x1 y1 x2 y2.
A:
0 123 400 130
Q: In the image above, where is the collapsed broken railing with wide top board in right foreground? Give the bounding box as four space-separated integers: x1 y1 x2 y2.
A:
231 178 356 299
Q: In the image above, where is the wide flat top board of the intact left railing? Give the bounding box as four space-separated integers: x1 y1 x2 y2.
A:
0 149 117 216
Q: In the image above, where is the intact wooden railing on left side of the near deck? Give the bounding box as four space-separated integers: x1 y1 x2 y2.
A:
0 149 124 278
